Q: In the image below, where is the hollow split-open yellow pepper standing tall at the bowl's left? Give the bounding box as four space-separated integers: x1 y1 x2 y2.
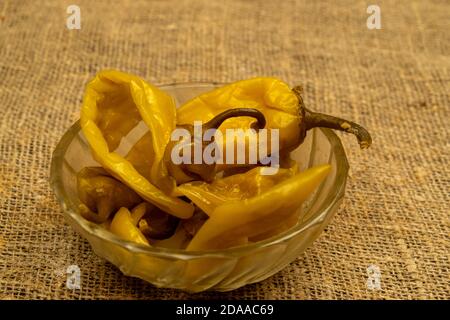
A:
80 71 194 219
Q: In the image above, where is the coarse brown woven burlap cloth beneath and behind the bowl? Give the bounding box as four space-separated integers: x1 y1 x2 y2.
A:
0 0 450 299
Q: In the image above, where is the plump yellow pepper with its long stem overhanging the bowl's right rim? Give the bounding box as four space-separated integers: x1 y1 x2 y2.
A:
171 78 372 182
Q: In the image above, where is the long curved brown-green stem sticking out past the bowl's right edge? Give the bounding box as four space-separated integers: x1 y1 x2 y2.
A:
292 86 372 149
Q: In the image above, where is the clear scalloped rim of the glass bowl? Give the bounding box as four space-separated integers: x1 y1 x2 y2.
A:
50 82 349 259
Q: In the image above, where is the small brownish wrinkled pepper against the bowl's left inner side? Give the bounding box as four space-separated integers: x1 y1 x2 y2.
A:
77 167 142 223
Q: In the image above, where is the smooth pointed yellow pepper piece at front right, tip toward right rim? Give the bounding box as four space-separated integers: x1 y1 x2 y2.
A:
187 165 331 251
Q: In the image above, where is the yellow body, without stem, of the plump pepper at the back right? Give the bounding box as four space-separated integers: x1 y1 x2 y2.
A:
177 78 302 171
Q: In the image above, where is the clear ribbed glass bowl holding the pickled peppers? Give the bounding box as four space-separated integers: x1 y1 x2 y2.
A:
50 84 348 292
